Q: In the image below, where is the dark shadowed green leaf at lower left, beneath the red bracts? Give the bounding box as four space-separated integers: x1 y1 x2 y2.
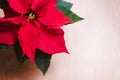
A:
13 44 28 64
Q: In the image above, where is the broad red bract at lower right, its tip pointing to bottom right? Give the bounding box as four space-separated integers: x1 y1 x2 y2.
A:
33 22 68 54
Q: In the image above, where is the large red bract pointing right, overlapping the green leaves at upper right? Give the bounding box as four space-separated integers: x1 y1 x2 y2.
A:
38 0 72 28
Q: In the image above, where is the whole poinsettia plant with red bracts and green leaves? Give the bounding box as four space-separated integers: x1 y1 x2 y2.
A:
0 0 83 74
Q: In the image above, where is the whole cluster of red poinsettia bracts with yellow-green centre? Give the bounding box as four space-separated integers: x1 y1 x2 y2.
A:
0 0 71 61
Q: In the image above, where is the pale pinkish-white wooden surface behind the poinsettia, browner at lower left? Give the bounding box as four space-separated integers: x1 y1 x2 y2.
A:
0 0 120 80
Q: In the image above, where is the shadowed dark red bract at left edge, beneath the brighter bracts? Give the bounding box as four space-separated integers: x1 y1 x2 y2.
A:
0 19 20 46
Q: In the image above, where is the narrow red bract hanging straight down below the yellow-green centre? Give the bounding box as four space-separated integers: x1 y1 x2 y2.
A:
18 23 38 62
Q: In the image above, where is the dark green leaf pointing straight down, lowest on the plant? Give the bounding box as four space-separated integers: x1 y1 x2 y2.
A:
35 49 52 75
